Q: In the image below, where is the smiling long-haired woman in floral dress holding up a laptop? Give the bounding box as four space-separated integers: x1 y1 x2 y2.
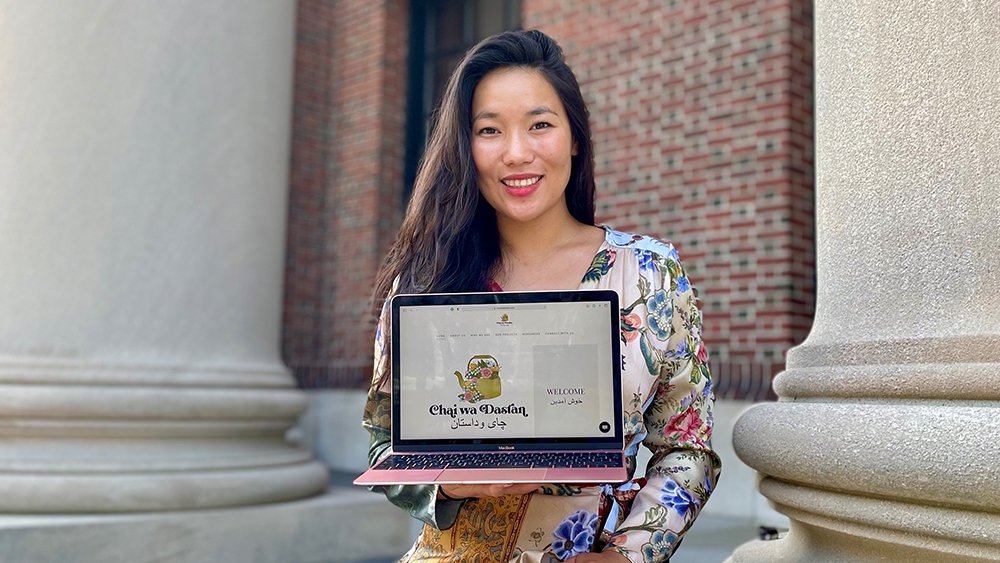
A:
364 31 720 563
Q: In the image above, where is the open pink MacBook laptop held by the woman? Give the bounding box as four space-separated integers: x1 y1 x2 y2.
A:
354 290 627 485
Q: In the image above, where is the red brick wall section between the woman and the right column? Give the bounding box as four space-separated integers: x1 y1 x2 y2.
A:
523 0 814 399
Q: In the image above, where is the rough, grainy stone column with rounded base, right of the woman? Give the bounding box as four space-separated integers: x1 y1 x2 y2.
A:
730 0 1000 563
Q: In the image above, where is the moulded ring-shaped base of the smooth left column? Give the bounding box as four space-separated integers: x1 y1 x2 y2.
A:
0 362 330 514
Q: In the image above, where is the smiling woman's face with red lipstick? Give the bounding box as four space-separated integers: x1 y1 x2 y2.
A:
472 68 576 229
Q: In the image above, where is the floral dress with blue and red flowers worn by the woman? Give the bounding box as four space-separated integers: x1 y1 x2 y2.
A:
363 228 721 563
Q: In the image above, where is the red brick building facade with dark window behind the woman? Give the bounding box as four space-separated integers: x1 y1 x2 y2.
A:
282 0 815 401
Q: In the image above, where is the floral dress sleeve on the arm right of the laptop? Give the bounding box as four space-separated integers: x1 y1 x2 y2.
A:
605 239 721 563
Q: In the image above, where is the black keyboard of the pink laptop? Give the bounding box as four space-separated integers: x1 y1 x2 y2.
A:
376 452 622 469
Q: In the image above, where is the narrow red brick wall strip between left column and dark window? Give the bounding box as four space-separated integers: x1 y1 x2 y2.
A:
282 0 409 388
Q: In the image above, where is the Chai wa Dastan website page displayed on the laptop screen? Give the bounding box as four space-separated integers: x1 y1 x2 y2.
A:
399 303 618 440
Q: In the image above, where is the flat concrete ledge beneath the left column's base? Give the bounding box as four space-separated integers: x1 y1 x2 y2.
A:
0 487 411 563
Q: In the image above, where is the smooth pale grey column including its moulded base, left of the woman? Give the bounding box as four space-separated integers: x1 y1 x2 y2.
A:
0 0 326 514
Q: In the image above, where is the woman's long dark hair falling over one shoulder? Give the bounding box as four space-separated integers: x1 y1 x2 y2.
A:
374 30 594 376
